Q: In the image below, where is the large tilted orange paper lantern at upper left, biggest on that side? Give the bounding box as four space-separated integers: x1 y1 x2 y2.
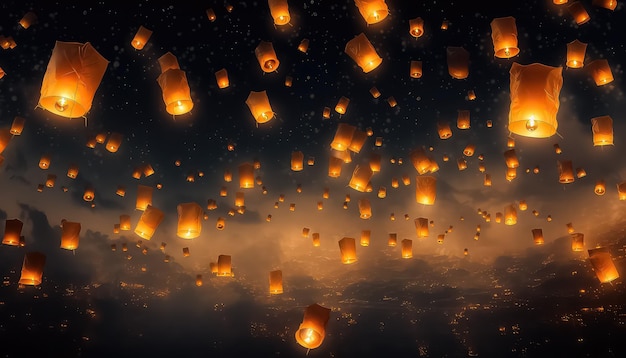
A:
38 41 109 118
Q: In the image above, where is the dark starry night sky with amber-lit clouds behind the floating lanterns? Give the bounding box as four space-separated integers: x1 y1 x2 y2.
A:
0 0 626 357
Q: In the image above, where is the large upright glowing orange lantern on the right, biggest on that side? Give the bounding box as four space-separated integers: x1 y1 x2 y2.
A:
509 62 563 138
